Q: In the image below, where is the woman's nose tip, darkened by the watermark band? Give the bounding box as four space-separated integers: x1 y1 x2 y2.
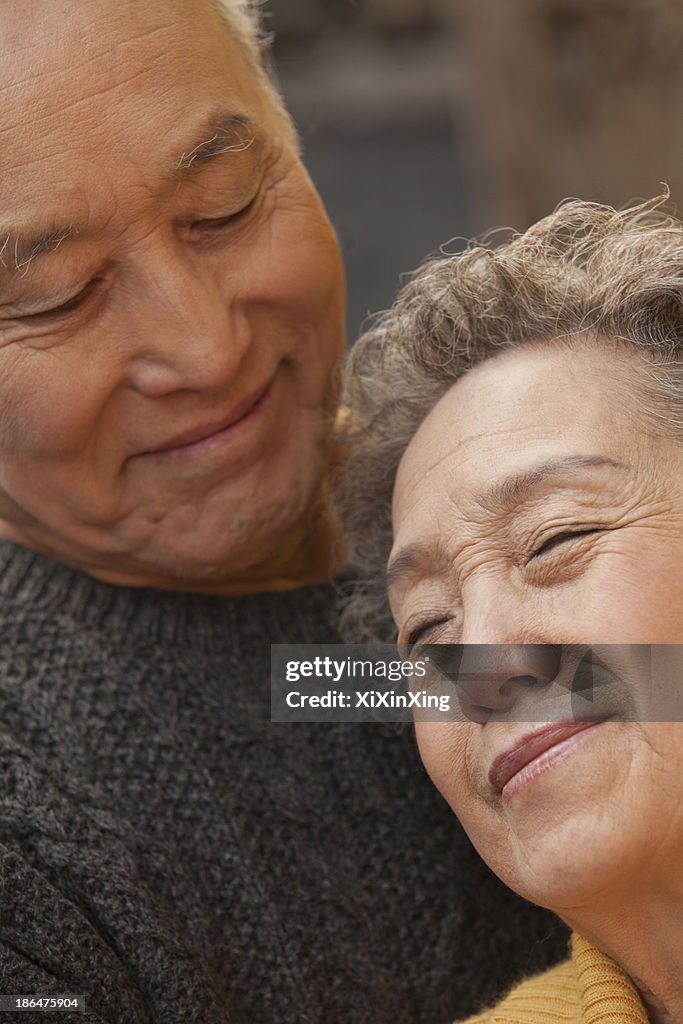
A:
429 643 562 724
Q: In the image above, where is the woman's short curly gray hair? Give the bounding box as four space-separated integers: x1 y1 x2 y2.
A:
337 197 683 642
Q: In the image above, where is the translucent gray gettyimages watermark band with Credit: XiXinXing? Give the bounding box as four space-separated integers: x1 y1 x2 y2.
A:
270 644 683 723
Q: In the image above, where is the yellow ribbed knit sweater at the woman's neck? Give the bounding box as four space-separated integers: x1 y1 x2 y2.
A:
466 935 648 1024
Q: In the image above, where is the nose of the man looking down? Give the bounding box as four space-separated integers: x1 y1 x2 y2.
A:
128 244 251 397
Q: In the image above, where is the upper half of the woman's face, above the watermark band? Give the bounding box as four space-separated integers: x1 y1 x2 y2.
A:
391 343 683 643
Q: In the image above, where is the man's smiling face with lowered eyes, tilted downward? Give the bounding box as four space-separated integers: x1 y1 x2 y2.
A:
0 0 343 587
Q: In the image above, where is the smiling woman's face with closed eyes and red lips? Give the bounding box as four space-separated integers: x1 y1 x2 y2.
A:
390 342 683 913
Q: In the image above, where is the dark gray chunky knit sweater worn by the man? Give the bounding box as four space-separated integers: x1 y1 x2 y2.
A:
0 542 565 1024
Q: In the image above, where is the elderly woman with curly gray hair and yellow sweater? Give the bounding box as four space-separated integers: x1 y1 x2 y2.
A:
343 195 683 1024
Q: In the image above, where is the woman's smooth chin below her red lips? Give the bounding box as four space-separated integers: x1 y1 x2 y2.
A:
463 723 657 909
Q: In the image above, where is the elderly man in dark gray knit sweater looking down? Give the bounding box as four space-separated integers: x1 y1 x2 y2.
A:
0 0 561 1024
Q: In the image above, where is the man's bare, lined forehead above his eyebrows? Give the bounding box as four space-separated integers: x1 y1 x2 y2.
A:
0 0 273 190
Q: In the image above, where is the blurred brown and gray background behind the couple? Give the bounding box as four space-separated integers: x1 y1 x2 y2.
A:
265 0 683 339
